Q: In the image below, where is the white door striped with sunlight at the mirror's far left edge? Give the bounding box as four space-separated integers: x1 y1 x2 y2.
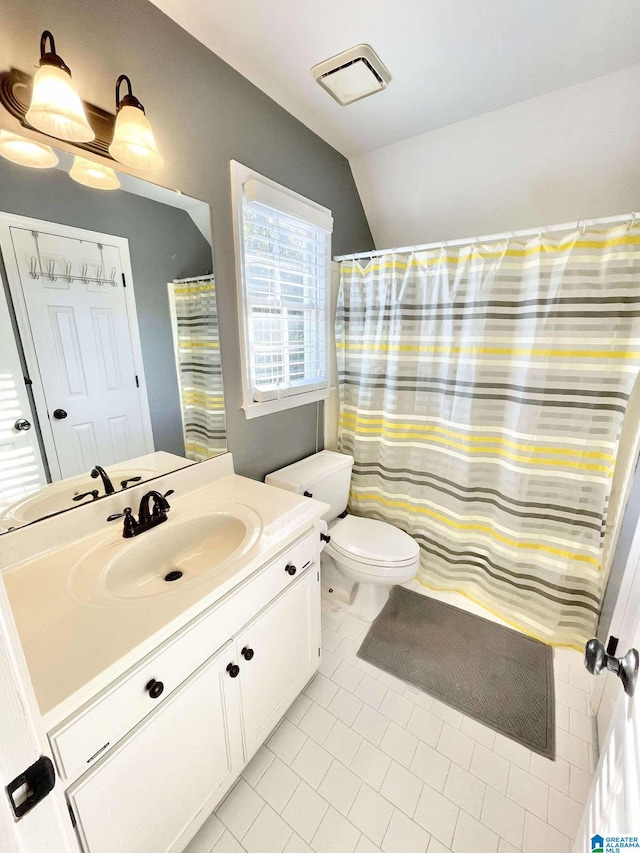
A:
0 281 47 516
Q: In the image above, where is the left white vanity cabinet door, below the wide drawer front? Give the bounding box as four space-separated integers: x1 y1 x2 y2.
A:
67 642 243 853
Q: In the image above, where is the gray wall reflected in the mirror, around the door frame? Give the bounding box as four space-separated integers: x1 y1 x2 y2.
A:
0 158 212 461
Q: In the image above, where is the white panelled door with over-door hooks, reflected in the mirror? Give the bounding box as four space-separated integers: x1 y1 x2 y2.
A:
4 226 153 479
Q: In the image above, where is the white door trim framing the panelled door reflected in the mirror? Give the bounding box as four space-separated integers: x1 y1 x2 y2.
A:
0 212 154 481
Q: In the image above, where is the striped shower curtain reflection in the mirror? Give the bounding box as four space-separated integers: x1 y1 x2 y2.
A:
169 278 227 461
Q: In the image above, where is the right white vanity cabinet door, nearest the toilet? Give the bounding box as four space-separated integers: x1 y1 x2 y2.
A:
236 567 320 760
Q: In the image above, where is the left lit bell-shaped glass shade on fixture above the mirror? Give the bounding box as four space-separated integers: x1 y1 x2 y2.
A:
25 64 96 142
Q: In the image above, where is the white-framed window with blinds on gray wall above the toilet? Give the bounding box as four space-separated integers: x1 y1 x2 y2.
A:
231 161 333 418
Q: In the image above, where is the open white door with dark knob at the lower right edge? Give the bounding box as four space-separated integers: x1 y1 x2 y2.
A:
574 527 640 853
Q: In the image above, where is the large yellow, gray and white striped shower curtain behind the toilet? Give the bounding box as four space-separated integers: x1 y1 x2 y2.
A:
336 226 640 646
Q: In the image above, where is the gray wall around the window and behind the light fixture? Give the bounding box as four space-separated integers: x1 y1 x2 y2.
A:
0 0 373 478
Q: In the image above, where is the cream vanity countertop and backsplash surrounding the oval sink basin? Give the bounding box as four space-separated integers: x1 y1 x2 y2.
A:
0 454 327 728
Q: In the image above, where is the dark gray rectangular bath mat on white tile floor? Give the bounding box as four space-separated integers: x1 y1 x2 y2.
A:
358 586 555 758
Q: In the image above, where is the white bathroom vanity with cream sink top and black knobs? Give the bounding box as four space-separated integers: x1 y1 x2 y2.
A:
4 454 327 853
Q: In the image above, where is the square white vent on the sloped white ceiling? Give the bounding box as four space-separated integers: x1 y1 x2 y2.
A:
311 44 391 107
